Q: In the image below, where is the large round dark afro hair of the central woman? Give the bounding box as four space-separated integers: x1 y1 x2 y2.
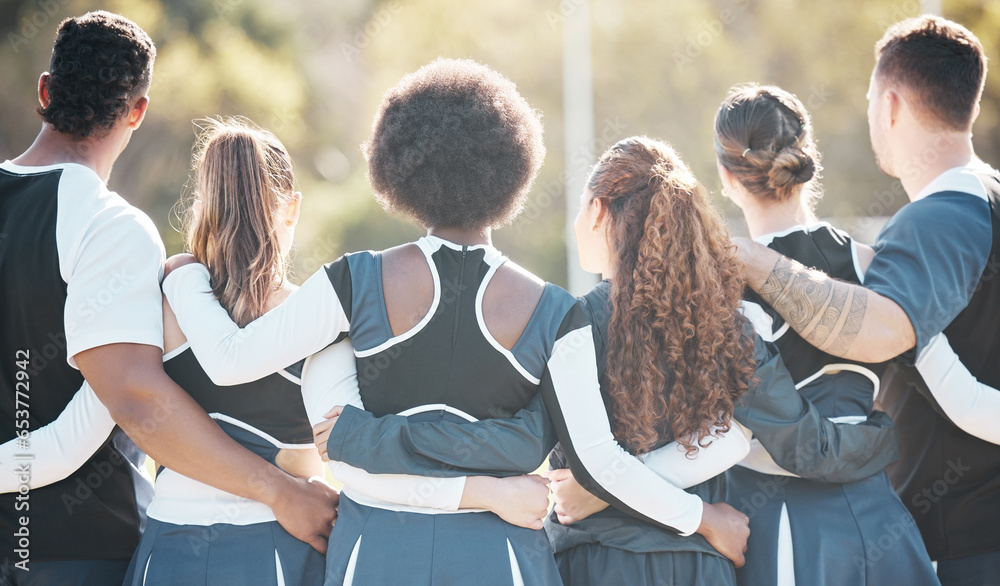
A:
361 59 545 229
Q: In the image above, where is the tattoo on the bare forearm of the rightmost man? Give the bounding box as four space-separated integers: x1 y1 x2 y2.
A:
759 257 868 355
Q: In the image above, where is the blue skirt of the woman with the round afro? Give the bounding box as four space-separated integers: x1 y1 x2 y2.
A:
325 494 561 586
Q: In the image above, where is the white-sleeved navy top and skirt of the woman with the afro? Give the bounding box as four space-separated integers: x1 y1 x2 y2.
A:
164 236 744 584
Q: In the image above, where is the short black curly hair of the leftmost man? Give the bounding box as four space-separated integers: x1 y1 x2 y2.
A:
36 11 156 138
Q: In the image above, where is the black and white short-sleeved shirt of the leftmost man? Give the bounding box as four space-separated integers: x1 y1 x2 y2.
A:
0 162 164 584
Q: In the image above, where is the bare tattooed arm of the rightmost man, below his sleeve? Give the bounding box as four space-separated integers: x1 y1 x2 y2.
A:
736 238 916 362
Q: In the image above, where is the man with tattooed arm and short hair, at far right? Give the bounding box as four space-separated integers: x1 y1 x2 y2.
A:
740 16 1000 585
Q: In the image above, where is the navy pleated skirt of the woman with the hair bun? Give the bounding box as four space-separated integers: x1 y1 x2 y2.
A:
726 466 940 586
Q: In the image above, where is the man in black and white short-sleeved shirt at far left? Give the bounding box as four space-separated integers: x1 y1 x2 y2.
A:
0 12 336 585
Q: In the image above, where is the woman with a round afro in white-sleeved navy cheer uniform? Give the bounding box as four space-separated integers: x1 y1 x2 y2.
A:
163 59 746 585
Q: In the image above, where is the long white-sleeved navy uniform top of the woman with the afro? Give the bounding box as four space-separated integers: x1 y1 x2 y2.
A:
164 236 740 534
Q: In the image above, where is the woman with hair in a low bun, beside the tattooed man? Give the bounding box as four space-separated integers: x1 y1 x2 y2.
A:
715 85 938 586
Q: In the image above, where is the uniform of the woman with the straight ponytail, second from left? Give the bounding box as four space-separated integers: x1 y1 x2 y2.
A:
125 344 325 586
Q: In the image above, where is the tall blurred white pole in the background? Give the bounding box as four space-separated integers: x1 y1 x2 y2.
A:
563 0 597 295
